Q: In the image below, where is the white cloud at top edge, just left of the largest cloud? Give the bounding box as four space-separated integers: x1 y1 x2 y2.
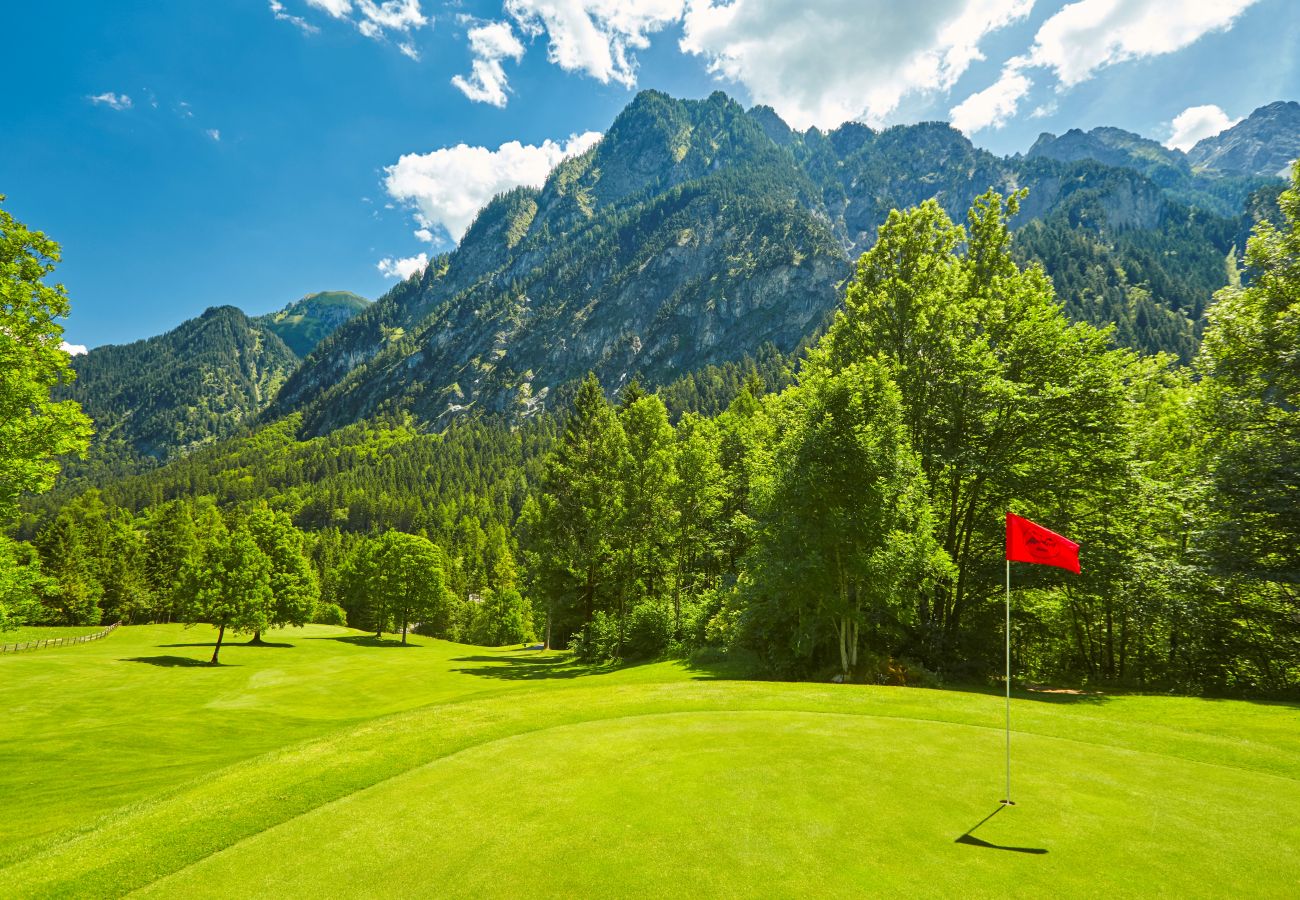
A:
506 0 686 87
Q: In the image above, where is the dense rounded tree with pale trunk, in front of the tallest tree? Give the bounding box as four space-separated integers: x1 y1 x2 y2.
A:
744 360 949 678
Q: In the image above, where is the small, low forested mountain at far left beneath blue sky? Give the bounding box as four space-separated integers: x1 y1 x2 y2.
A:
61 306 298 470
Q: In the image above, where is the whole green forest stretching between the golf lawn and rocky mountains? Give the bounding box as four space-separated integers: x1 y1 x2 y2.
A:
0 168 1300 696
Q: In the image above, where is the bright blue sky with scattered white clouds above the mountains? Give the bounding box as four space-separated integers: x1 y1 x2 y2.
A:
0 0 1300 346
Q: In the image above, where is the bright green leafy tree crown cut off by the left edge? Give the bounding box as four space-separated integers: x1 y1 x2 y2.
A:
0 195 91 520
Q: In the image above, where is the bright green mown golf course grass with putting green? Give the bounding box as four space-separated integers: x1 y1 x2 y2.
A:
0 626 1300 896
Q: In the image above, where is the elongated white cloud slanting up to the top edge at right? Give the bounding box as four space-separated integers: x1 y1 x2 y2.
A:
950 0 1257 134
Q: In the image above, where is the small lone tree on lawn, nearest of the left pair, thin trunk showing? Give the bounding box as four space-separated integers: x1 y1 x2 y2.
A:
185 527 273 666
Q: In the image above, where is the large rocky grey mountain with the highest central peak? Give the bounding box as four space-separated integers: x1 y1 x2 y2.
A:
265 91 1245 433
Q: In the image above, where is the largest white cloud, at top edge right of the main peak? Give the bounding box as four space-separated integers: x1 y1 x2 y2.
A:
681 0 1034 129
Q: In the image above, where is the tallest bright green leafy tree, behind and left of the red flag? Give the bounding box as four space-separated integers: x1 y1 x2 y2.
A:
815 191 1125 667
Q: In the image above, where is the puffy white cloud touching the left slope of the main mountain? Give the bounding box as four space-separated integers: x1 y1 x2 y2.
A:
384 131 601 242
